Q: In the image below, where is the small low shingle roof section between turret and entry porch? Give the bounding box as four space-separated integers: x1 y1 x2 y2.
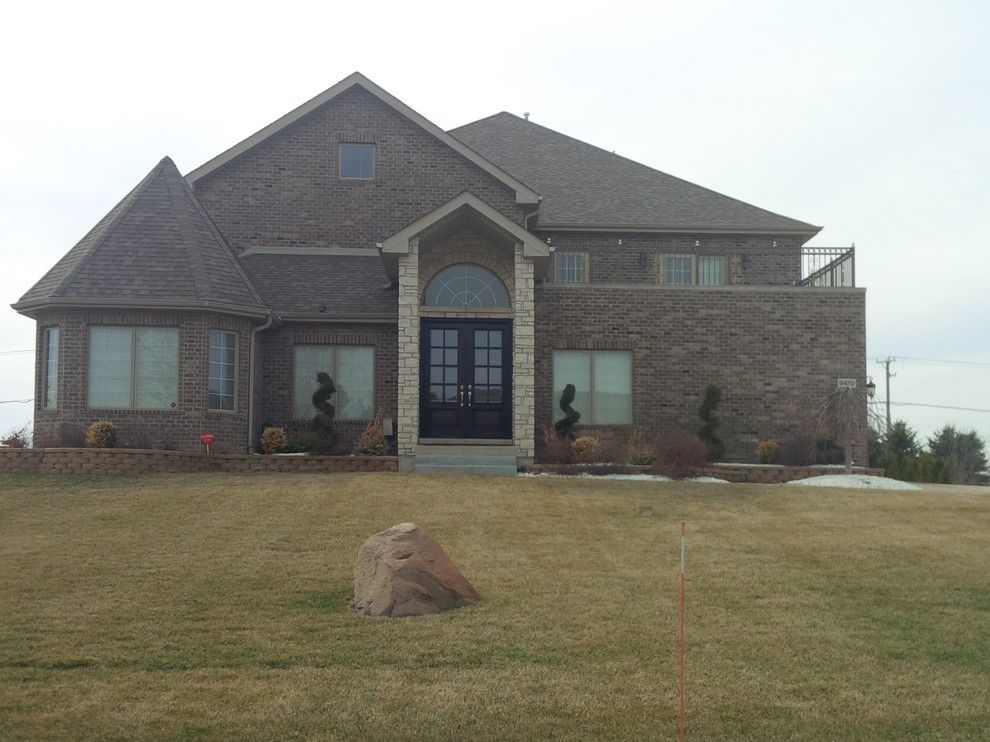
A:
240 249 399 317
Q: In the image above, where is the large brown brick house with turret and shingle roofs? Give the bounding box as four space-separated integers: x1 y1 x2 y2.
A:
13 73 866 468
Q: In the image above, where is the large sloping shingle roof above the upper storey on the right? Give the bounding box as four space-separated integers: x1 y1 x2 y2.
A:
450 112 820 234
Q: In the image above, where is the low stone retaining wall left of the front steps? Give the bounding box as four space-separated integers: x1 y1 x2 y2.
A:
0 448 398 474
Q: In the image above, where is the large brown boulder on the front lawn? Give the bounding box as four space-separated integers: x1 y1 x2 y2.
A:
351 523 478 616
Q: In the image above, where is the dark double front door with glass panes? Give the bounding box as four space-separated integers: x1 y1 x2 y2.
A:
419 319 512 438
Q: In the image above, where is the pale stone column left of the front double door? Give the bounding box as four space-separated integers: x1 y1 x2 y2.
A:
396 238 419 470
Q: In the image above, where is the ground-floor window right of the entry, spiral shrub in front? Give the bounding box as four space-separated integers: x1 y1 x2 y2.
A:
553 350 632 425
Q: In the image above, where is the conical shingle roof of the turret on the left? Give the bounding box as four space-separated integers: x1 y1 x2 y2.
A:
14 157 266 314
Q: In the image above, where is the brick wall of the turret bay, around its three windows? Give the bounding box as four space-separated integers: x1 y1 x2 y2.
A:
34 310 252 452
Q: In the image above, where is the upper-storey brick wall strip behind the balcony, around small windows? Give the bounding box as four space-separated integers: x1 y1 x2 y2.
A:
538 231 804 286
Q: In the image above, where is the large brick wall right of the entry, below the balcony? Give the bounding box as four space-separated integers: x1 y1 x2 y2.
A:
536 284 866 462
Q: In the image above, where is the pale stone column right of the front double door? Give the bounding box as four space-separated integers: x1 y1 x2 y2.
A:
512 244 536 463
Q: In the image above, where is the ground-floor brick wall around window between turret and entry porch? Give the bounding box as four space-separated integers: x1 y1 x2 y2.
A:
255 323 398 452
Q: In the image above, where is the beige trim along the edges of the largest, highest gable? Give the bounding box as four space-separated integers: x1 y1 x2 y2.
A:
186 72 540 204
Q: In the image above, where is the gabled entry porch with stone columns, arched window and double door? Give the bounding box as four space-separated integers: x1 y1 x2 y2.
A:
381 192 550 470
